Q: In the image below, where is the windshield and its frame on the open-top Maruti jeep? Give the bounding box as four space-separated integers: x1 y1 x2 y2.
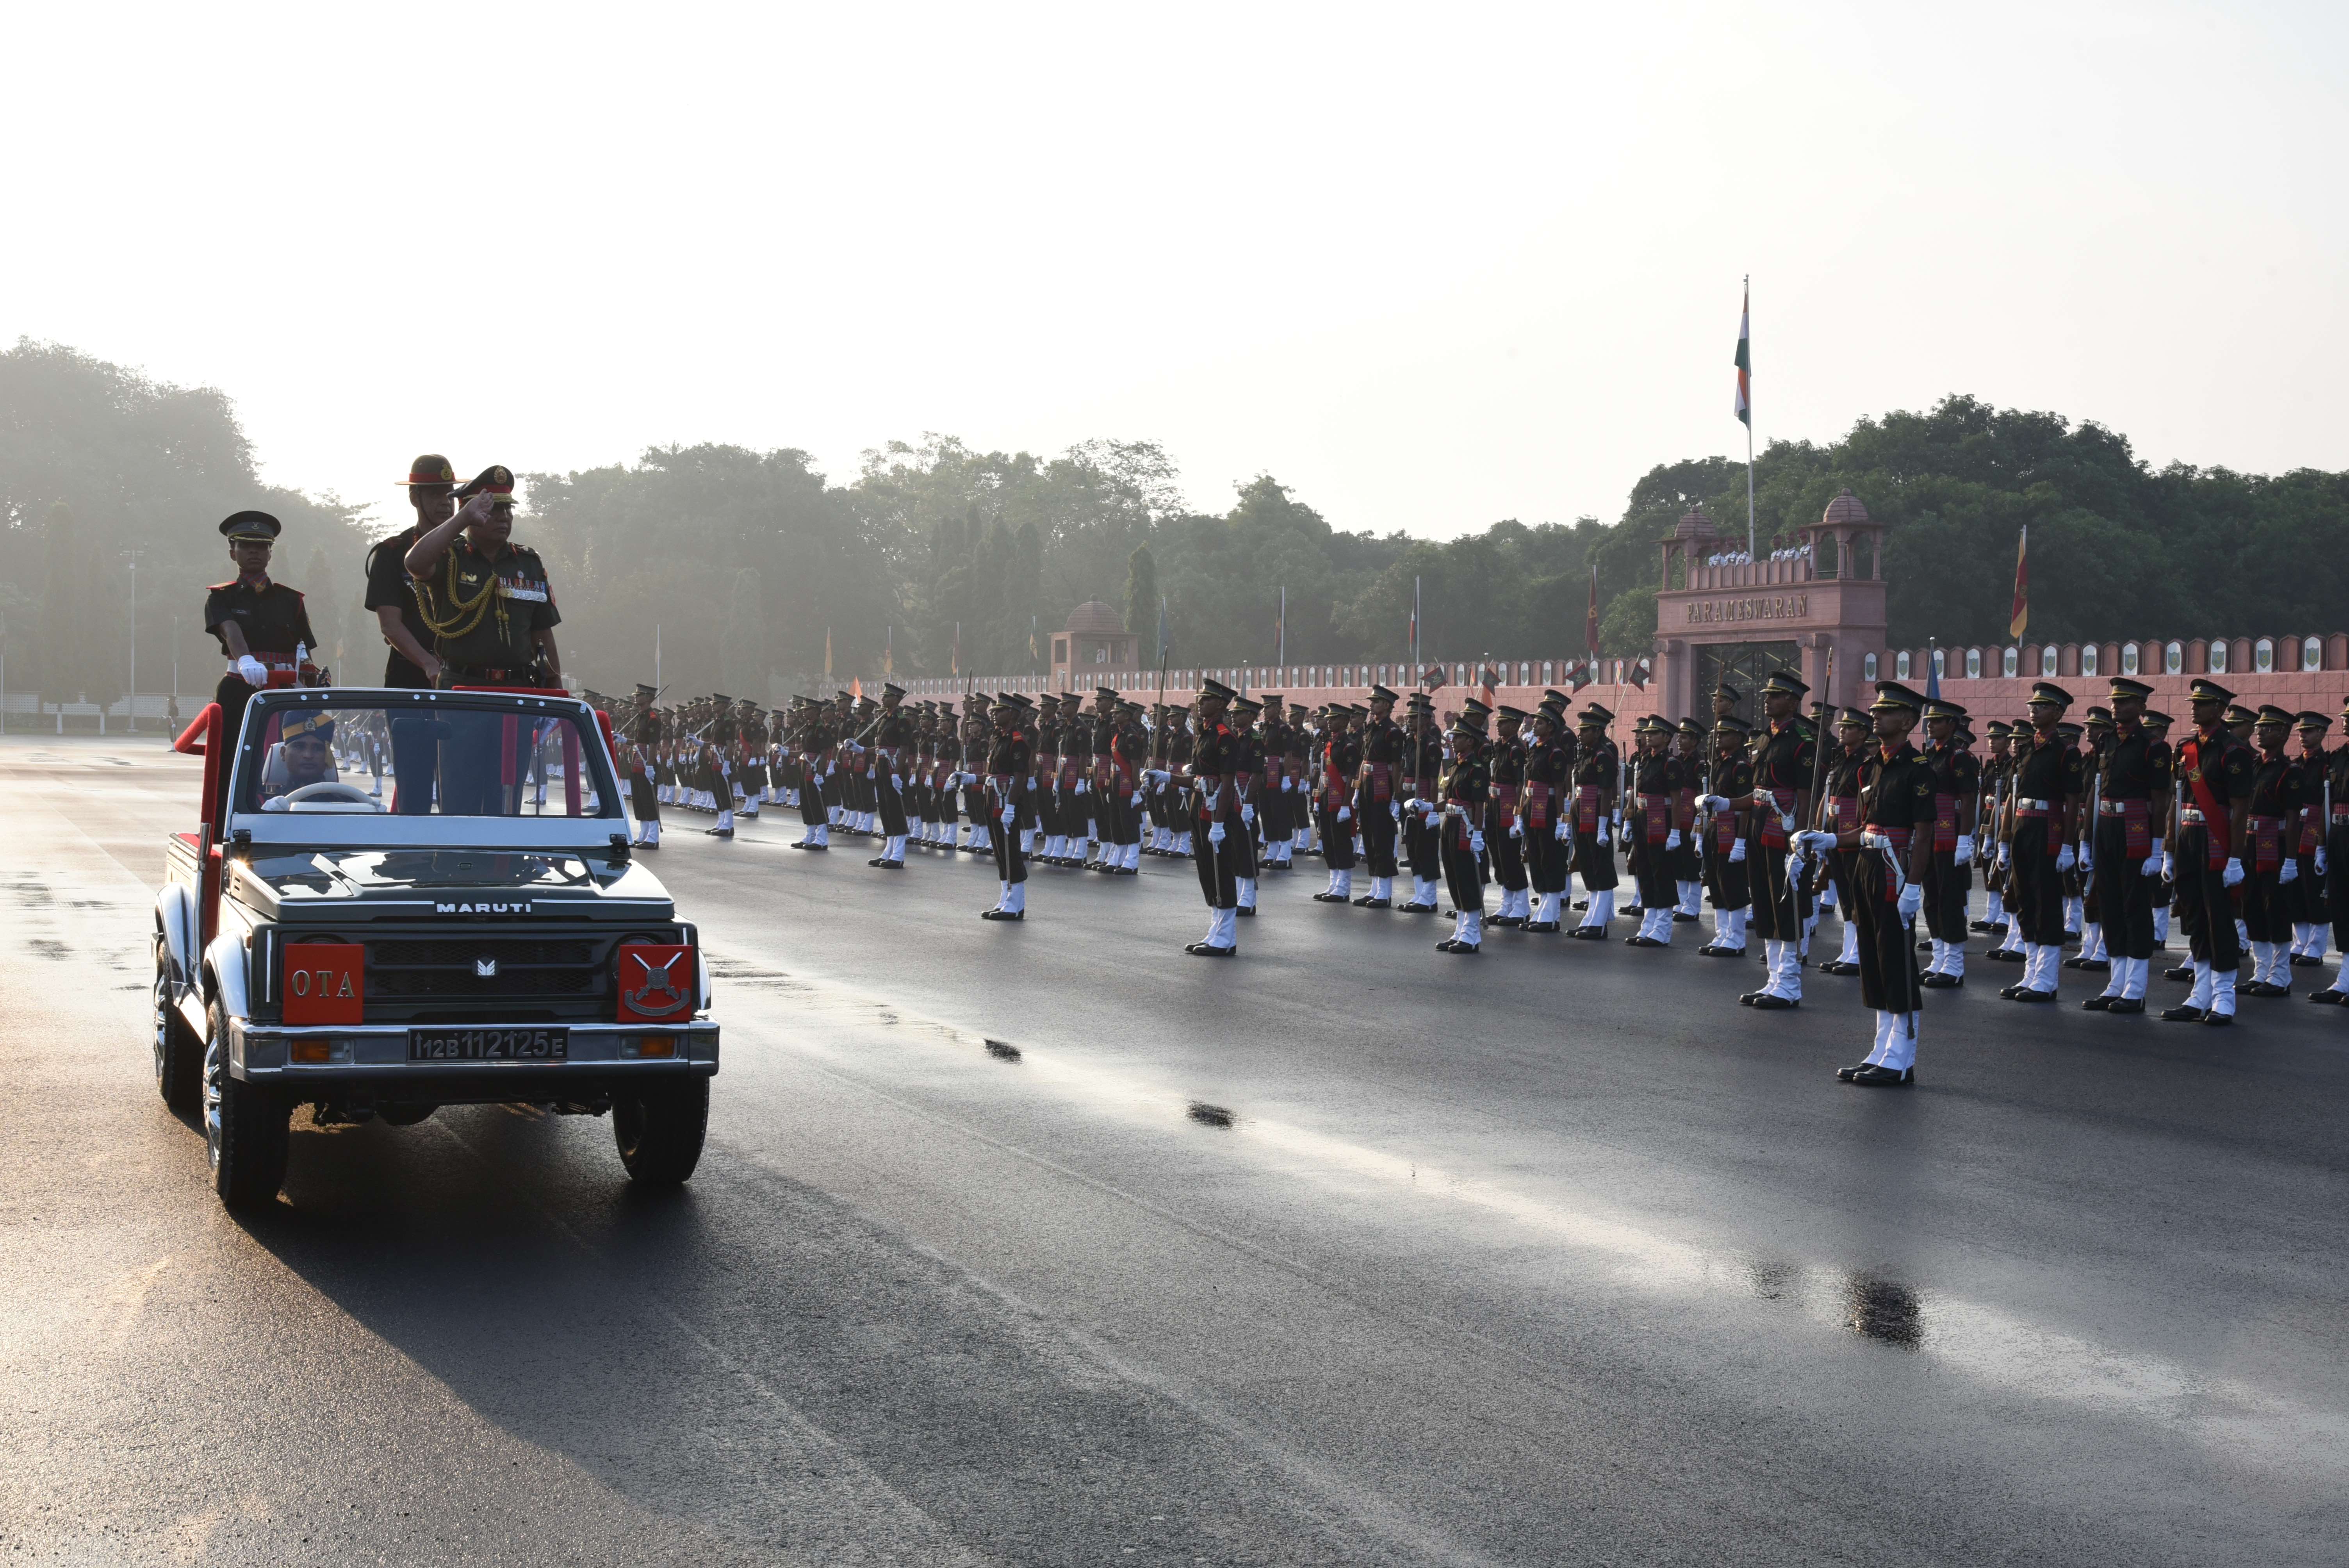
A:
226 685 629 852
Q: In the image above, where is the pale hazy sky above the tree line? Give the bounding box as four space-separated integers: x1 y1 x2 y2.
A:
0 0 2349 533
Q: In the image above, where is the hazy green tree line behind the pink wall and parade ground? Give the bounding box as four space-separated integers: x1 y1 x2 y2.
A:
0 343 2349 700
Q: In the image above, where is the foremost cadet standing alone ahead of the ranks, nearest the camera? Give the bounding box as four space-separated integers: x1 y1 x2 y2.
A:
1795 681 1938 1089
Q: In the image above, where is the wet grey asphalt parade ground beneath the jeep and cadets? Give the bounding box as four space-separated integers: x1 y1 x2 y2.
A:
0 737 2349 1566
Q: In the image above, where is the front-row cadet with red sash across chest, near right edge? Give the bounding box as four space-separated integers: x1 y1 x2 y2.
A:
2161 678 2257 1023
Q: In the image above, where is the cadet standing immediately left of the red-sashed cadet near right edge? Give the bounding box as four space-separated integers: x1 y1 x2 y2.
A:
2081 676 2171 1012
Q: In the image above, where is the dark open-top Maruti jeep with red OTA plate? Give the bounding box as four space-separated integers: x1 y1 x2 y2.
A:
155 688 719 1206
